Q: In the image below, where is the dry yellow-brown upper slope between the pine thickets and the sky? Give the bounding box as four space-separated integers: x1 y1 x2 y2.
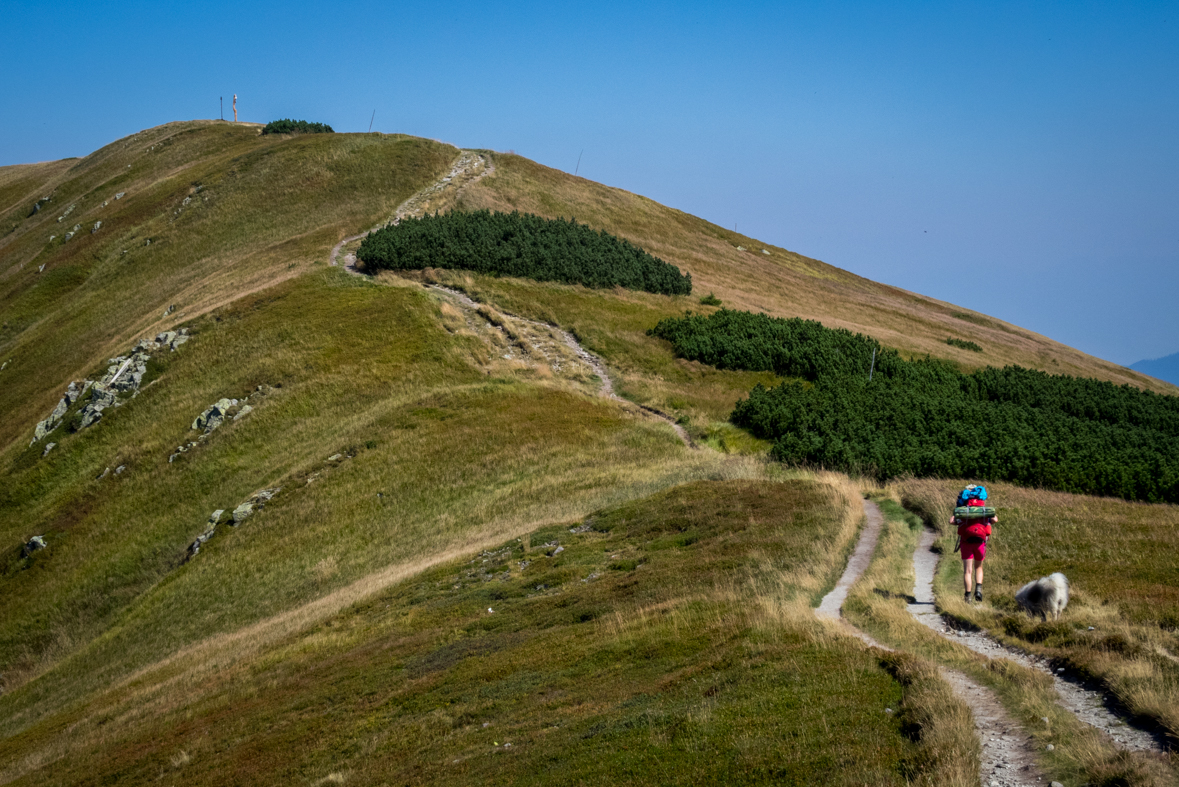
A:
457 154 1177 394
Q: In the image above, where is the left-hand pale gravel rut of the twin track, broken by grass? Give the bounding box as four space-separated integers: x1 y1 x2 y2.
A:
815 500 1046 787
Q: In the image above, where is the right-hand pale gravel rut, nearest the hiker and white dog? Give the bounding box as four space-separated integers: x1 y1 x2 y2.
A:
909 529 1164 753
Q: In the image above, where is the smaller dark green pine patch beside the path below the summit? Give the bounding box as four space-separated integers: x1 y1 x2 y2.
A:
356 211 692 295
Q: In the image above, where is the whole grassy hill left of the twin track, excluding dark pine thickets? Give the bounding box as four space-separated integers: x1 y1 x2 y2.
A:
0 121 1175 785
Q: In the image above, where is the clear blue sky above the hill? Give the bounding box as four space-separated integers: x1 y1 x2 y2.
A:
0 0 1179 364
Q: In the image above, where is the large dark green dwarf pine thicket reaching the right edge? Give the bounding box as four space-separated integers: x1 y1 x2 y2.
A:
652 310 1179 502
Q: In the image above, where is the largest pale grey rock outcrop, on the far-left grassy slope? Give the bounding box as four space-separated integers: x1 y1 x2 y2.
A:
29 328 190 447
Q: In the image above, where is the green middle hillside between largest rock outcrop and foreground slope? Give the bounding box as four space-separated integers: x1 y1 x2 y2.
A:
0 272 764 732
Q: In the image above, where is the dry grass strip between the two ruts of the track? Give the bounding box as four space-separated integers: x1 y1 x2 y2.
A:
844 490 1175 787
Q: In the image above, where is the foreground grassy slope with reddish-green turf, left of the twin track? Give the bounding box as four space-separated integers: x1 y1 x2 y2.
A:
0 480 946 785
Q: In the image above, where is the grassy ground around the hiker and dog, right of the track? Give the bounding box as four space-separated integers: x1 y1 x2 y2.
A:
891 480 1179 740
